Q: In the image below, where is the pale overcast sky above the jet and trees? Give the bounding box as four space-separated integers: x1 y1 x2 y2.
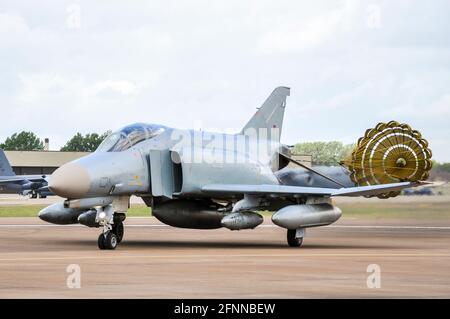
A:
0 0 450 161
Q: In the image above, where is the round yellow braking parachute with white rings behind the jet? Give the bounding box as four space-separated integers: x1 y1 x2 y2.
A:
342 121 432 198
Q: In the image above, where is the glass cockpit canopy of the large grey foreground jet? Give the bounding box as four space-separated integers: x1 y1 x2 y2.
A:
96 123 165 152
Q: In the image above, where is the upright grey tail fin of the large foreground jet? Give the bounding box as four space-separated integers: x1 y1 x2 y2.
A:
241 86 290 139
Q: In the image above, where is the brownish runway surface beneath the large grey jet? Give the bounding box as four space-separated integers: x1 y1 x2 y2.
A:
0 218 450 298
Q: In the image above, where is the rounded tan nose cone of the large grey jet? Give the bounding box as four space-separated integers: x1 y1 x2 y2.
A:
48 163 91 198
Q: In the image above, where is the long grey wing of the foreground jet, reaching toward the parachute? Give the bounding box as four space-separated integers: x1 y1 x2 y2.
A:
202 182 426 197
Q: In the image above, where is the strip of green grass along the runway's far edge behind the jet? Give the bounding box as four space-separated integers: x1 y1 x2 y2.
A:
0 202 450 219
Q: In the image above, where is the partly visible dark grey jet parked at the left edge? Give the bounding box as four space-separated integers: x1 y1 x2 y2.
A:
0 150 53 198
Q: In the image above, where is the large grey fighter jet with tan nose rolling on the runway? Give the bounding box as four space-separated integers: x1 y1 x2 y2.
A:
39 87 428 249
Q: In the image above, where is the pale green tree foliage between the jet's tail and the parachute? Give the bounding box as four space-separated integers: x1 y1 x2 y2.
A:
294 141 354 166
